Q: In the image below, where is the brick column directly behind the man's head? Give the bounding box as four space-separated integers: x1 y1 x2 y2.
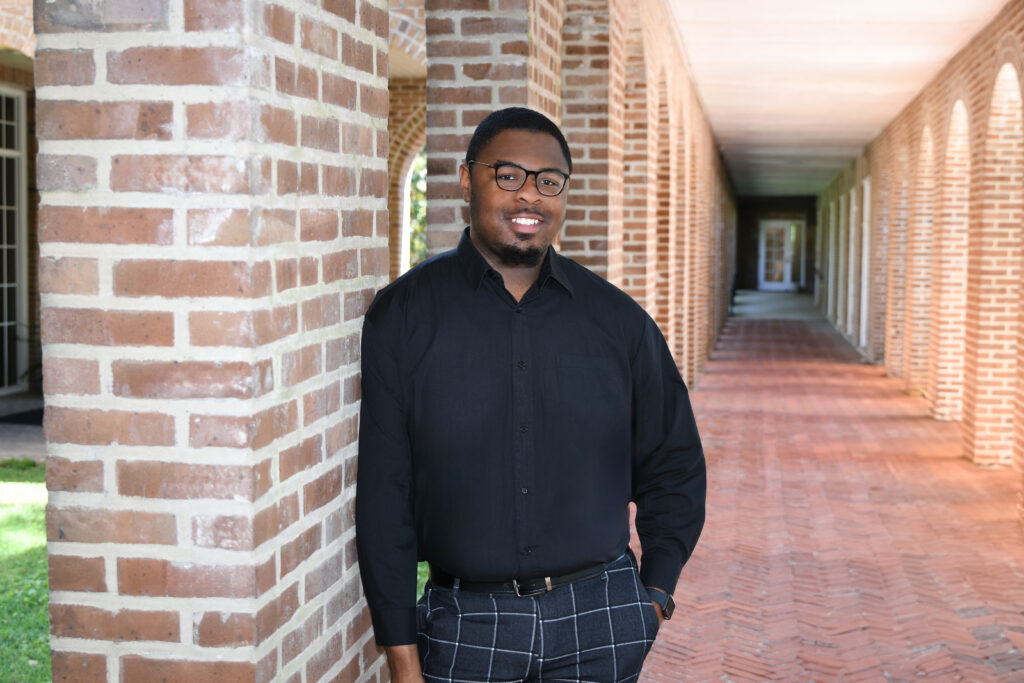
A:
426 0 562 254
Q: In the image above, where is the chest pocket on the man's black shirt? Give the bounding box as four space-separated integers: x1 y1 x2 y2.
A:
557 353 630 417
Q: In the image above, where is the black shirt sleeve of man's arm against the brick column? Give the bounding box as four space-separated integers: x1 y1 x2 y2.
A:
355 307 417 647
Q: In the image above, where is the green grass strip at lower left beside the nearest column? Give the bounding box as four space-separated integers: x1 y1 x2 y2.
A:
0 460 50 683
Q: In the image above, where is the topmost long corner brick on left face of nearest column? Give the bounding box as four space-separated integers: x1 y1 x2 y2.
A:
106 46 247 85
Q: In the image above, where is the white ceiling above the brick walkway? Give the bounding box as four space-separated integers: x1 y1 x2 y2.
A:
668 0 1007 195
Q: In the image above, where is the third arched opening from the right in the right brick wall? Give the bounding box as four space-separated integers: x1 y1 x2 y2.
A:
903 126 935 393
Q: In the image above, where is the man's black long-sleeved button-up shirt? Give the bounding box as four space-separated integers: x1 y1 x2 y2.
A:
356 230 707 645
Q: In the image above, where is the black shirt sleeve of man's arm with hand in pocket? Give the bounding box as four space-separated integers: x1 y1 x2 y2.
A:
633 315 708 595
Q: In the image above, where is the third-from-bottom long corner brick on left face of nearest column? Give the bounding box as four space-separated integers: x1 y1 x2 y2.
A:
118 460 258 501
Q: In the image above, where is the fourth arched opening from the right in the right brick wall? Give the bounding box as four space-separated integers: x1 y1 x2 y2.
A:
885 142 909 377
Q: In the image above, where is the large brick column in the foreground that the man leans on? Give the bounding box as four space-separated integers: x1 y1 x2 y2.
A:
36 0 388 681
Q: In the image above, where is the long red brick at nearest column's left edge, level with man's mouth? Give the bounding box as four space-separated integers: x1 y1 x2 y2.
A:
39 206 174 245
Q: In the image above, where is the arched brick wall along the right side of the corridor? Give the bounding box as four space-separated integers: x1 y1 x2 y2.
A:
821 0 1024 514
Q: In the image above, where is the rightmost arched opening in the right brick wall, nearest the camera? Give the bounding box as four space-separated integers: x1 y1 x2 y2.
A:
964 63 1024 463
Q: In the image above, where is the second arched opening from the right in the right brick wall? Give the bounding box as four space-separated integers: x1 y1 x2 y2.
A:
927 100 971 420
